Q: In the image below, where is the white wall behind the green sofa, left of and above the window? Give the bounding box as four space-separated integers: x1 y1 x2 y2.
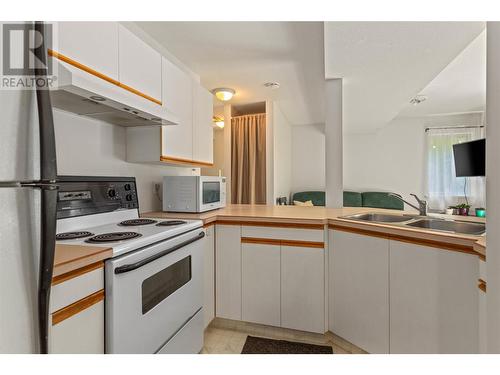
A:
344 113 482 206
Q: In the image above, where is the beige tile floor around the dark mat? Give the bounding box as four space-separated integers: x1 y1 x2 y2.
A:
201 318 366 354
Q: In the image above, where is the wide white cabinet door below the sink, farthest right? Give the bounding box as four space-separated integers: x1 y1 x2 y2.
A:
390 241 478 353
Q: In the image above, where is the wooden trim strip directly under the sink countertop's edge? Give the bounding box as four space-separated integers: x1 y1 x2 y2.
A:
328 224 479 256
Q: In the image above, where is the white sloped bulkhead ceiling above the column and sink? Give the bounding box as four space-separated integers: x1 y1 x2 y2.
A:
324 22 484 132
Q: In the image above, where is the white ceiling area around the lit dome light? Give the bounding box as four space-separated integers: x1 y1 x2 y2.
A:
136 22 324 125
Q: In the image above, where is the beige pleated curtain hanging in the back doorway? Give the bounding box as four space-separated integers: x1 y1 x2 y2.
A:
231 113 266 204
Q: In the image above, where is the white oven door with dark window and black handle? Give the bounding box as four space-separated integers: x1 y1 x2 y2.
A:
105 228 205 353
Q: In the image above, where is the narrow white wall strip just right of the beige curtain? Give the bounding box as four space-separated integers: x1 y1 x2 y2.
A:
274 103 292 204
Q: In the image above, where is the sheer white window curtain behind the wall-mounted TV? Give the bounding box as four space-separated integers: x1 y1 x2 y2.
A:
426 127 486 210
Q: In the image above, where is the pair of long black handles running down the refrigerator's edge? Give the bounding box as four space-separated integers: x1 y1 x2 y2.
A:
31 21 57 354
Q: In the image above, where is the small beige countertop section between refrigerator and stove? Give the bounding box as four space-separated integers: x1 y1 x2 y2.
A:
52 244 113 278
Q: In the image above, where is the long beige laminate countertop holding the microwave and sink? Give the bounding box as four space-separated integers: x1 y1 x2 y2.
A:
141 205 486 258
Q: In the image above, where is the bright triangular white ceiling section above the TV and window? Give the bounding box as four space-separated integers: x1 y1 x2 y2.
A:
398 30 486 117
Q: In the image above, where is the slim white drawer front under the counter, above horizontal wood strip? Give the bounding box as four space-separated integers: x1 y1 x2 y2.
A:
241 226 324 242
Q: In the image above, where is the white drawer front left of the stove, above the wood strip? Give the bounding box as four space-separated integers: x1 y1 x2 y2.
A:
50 265 104 313
